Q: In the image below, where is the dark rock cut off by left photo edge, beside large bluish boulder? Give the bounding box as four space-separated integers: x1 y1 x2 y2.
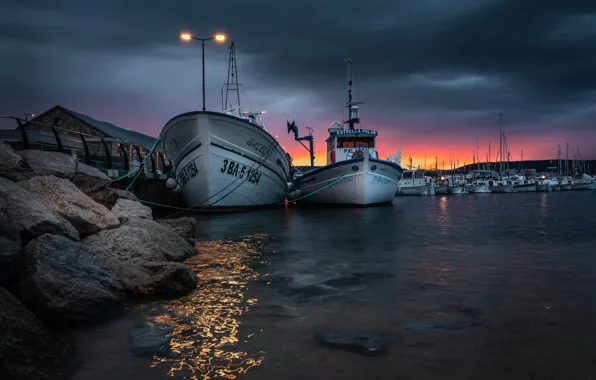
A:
0 214 23 284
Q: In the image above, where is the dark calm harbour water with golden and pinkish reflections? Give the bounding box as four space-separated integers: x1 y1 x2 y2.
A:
73 191 596 380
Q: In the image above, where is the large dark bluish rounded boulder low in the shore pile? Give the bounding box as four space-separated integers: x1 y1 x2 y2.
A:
12 234 123 325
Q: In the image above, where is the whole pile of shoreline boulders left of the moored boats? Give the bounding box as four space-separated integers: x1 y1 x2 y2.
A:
0 141 197 379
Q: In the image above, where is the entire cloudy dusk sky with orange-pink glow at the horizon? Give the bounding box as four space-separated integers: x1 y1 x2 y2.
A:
0 0 596 166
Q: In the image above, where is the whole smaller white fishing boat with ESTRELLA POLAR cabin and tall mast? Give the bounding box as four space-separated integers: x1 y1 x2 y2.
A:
288 59 403 206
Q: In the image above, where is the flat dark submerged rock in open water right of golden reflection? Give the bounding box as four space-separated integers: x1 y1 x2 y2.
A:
315 331 385 355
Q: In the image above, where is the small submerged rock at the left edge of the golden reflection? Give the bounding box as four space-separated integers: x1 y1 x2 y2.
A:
130 325 174 356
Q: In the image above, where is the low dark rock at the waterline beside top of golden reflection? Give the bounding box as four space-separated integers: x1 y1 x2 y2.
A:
118 259 197 296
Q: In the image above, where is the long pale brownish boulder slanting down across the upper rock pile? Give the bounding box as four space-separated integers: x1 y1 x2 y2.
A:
19 176 120 236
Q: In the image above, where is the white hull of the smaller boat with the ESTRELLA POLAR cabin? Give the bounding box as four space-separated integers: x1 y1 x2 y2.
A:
288 157 402 206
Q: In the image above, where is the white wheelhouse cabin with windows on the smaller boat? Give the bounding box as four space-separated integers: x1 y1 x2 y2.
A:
326 126 379 165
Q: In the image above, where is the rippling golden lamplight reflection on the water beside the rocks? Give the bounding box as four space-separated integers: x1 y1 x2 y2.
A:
149 235 266 380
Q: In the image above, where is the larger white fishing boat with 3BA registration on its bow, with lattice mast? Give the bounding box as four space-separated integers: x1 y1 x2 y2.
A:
161 42 290 209
